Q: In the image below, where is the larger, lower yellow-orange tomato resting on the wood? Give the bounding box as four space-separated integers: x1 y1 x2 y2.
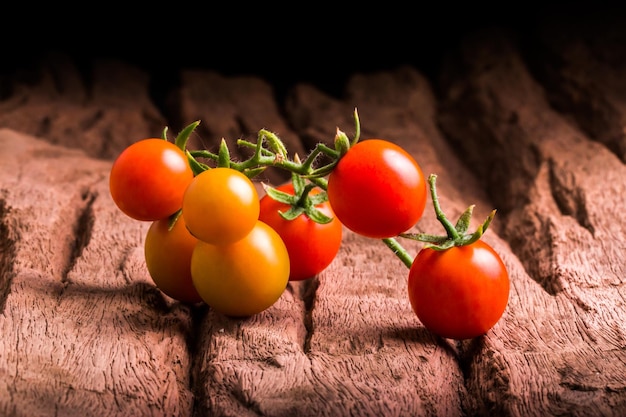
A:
191 221 289 317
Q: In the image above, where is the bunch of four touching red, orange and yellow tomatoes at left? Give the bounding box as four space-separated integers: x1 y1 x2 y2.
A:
109 138 289 316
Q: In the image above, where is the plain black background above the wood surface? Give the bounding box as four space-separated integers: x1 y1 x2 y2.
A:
0 1 622 94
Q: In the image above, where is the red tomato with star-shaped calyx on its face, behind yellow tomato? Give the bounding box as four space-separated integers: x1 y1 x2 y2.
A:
259 176 343 281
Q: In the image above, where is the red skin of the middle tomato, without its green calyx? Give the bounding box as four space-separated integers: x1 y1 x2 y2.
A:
259 182 343 281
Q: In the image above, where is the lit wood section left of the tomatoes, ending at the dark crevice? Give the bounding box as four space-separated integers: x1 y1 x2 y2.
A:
0 129 193 416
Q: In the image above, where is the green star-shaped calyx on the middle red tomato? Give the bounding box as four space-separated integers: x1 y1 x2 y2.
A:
263 171 333 224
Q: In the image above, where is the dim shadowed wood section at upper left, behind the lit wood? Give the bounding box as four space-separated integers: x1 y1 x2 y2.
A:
0 53 166 159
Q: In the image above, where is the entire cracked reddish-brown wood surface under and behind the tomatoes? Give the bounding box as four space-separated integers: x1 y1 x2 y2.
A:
0 13 626 416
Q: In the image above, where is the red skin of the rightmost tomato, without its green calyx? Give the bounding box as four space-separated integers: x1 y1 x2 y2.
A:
408 240 510 340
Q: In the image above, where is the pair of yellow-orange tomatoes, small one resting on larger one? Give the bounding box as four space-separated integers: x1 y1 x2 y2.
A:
181 167 289 316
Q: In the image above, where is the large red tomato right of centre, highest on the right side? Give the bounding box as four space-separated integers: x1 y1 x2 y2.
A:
328 139 427 239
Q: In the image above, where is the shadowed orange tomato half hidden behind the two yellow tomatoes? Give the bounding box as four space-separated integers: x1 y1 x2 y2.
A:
144 216 202 303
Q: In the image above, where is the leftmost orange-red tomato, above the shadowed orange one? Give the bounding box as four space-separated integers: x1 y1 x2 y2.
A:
109 138 193 221
